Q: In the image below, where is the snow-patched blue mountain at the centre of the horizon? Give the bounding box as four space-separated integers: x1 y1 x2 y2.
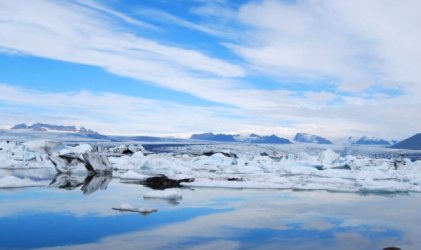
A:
190 133 291 144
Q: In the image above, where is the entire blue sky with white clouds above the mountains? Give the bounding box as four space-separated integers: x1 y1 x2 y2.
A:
0 0 421 139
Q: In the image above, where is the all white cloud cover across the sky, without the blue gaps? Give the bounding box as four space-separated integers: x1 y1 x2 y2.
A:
0 0 421 138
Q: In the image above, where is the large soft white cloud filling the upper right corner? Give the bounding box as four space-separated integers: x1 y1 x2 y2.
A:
228 0 421 91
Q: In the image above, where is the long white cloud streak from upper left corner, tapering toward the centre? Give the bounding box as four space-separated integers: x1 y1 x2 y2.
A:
0 1 244 80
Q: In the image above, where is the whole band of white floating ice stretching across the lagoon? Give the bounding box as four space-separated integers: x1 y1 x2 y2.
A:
0 140 421 193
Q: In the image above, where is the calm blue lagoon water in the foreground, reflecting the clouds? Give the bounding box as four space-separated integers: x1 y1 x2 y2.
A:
0 174 421 250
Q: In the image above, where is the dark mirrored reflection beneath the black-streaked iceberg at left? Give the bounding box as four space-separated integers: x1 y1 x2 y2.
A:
50 173 112 195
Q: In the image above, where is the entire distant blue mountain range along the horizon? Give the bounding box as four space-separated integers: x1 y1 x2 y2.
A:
6 123 421 150
